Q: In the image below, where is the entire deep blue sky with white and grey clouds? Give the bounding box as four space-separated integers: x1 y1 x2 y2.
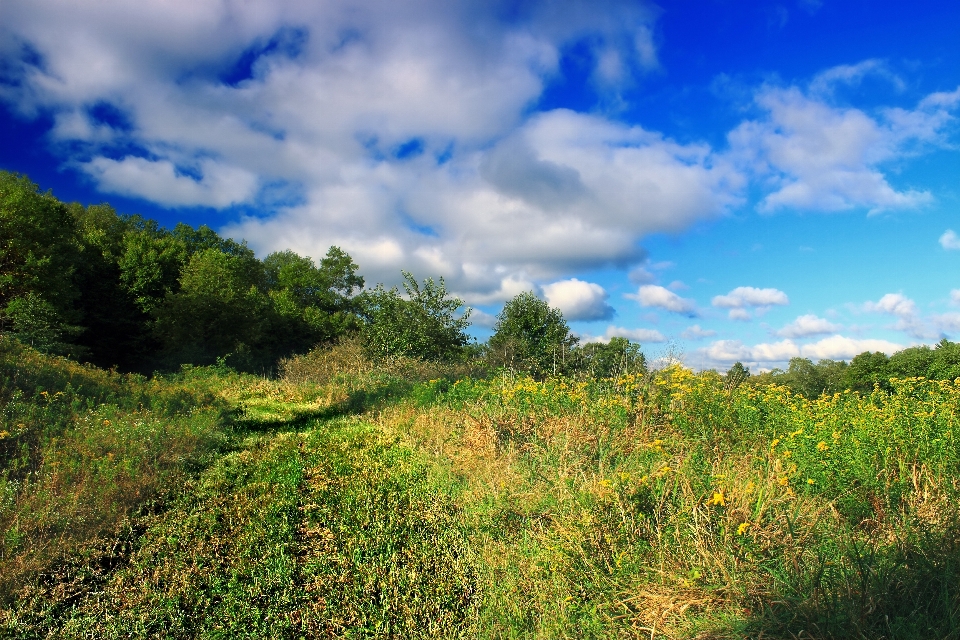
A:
0 0 960 371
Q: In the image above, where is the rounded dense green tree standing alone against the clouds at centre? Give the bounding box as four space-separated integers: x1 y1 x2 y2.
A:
488 291 579 378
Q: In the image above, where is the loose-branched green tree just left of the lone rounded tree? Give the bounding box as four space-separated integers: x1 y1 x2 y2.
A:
363 271 471 361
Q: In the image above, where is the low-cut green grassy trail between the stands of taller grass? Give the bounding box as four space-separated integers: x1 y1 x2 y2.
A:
7 406 478 638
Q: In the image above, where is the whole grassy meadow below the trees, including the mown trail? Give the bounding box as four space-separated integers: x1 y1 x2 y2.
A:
0 339 960 639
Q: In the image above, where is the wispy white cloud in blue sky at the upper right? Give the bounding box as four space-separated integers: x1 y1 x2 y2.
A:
728 66 958 212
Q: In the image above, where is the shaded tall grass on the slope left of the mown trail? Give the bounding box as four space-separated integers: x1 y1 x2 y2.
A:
0 337 229 607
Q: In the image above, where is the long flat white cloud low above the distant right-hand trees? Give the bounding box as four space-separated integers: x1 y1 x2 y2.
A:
697 334 904 367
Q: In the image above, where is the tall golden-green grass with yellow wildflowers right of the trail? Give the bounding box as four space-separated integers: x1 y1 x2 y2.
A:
381 367 960 638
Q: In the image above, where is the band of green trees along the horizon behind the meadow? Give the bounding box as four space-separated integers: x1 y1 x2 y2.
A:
7 171 960 390
